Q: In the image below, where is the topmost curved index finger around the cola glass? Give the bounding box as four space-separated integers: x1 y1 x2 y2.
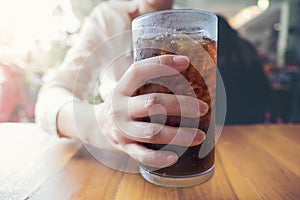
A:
119 55 189 96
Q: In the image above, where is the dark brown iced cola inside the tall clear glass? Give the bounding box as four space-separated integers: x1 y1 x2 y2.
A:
134 30 217 177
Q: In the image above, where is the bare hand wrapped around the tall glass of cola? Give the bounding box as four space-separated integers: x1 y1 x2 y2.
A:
96 55 208 167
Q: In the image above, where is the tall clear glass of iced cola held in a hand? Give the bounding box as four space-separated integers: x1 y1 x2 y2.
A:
132 9 217 187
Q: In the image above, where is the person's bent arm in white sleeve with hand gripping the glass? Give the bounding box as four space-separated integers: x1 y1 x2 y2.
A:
37 2 207 167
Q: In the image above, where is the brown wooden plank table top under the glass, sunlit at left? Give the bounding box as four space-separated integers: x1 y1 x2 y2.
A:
0 124 300 200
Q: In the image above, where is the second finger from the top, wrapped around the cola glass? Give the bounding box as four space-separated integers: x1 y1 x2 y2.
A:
128 93 208 118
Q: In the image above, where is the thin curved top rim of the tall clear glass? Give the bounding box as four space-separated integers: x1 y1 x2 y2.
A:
132 8 218 26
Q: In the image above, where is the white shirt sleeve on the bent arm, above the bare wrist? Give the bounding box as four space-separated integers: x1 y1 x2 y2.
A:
35 2 112 136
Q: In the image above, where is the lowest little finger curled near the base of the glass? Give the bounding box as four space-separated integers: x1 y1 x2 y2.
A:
123 143 178 168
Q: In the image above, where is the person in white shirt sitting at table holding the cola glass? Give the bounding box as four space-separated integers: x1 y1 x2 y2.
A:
36 0 208 167
